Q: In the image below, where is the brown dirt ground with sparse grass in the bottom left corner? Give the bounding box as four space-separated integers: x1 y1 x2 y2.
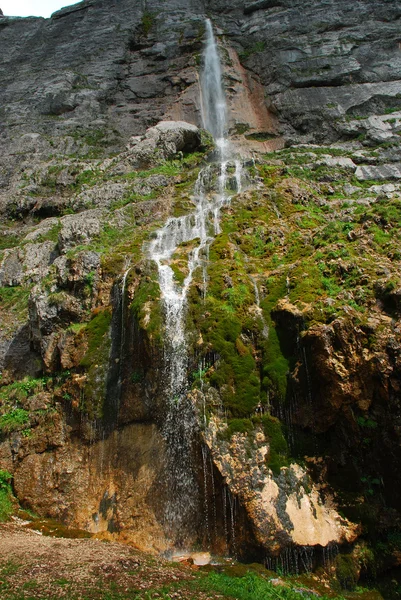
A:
0 523 219 600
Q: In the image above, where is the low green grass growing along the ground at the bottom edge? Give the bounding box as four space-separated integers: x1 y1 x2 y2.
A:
0 557 368 600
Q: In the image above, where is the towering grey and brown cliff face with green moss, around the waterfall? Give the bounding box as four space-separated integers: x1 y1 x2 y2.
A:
0 0 401 576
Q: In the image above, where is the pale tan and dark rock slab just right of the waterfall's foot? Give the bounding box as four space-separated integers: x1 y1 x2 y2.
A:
205 419 358 555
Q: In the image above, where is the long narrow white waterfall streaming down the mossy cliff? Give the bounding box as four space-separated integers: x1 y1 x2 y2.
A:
149 20 242 547
